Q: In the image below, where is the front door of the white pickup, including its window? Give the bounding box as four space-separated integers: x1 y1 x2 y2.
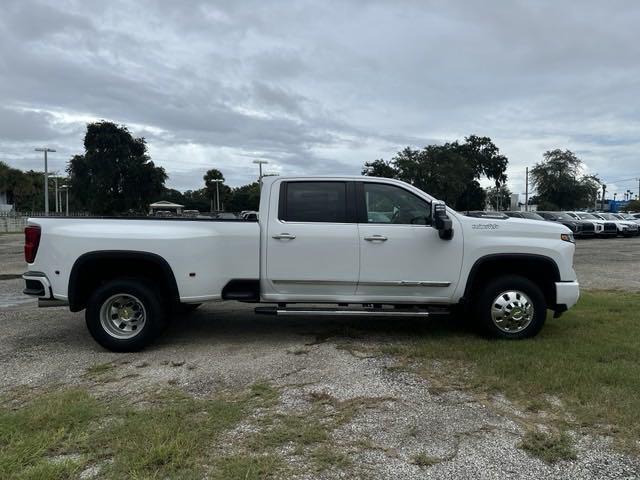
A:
357 182 462 302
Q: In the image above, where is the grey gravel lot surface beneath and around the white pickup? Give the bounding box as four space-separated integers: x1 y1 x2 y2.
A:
0 235 640 479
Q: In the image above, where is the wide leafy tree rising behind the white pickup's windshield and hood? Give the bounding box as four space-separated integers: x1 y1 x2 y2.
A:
362 135 508 210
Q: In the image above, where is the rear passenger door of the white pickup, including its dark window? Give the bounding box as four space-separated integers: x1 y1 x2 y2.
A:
263 180 360 300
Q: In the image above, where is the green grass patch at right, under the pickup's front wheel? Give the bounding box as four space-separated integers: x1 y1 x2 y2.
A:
384 292 640 452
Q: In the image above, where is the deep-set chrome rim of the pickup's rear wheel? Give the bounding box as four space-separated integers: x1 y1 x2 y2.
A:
100 293 147 339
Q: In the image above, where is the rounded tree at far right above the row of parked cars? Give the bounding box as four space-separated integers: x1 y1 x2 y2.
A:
531 149 600 210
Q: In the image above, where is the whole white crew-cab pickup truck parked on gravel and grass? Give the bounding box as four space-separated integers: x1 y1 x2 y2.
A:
23 177 579 351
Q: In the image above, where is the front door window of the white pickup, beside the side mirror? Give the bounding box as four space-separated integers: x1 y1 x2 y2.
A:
364 182 431 225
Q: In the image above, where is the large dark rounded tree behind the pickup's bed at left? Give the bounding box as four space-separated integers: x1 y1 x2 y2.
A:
67 121 167 215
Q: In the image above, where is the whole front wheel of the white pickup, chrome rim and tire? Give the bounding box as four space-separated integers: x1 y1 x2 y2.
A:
475 275 547 339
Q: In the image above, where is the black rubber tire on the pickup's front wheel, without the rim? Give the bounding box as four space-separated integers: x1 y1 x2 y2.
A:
473 275 547 340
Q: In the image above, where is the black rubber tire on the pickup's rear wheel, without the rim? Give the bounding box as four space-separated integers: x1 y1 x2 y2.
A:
85 278 165 352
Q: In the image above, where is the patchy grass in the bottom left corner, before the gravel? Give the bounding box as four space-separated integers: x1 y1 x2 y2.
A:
0 384 279 480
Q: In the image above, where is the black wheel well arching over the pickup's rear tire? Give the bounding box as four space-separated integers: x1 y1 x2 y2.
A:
68 251 180 312
